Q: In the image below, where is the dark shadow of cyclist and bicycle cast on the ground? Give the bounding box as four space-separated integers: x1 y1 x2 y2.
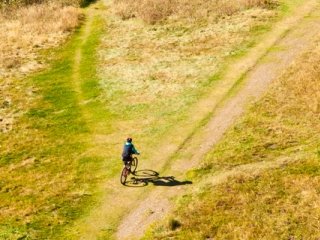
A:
125 169 192 187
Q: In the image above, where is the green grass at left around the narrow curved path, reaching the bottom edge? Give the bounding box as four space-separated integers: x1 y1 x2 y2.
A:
0 12 106 239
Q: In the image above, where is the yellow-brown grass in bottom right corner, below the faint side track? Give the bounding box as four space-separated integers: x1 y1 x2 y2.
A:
159 156 320 240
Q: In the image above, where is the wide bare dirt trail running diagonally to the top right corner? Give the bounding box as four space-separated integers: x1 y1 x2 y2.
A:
117 1 320 240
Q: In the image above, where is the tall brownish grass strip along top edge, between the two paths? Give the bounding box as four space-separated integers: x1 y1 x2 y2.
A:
115 0 275 24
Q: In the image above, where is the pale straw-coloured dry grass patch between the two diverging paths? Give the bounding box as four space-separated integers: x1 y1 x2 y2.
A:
101 5 275 114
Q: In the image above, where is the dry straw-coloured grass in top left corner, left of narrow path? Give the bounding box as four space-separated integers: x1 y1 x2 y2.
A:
0 3 81 133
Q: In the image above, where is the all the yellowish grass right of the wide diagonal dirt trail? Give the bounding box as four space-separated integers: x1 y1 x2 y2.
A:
145 30 320 239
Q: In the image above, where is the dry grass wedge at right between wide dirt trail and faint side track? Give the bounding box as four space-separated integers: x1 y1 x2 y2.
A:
195 37 320 169
